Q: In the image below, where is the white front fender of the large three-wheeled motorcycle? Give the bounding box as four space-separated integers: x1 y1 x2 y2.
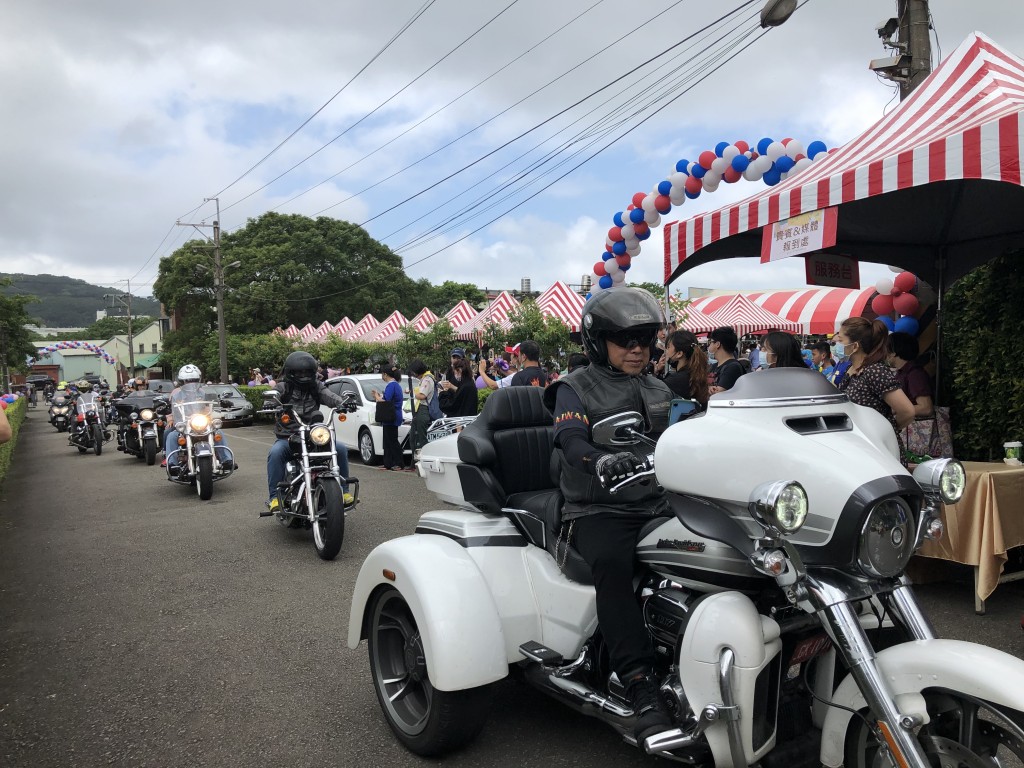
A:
821 640 1024 768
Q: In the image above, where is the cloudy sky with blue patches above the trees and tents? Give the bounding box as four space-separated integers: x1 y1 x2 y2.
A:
0 0 1024 303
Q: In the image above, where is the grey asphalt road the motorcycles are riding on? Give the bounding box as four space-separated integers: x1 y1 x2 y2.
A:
0 411 1024 768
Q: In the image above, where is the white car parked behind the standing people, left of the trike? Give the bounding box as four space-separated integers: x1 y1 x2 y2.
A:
321 374 420 465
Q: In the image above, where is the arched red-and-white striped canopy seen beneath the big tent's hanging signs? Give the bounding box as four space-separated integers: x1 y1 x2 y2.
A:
690 288 874 334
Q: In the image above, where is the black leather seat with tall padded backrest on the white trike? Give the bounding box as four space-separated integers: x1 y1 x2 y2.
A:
458 387 593 584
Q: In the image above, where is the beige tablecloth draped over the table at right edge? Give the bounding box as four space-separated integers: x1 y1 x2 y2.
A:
918 462 1024 600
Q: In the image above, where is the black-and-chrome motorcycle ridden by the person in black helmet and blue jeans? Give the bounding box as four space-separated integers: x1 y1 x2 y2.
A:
263 391 359 560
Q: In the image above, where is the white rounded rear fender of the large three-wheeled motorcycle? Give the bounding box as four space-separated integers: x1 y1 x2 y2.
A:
348 534 509 690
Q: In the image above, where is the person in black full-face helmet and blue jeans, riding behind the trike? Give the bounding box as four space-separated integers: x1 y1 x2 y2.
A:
260 351 352 517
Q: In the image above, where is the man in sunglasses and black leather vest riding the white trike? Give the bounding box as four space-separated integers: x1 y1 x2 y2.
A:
544 287 674 743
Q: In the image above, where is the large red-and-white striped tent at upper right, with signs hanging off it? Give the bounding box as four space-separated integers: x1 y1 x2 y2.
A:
665 33 1024 291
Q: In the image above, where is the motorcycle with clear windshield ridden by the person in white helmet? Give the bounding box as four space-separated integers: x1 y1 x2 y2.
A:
166 400 234 501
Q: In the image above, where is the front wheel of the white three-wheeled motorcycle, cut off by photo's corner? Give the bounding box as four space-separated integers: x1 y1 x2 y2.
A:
844 690 1024 768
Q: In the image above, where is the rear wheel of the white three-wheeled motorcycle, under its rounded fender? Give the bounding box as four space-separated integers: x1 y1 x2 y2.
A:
369 588 490 757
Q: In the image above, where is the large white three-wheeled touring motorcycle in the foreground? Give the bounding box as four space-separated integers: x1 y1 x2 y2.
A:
348 369 1024 768
